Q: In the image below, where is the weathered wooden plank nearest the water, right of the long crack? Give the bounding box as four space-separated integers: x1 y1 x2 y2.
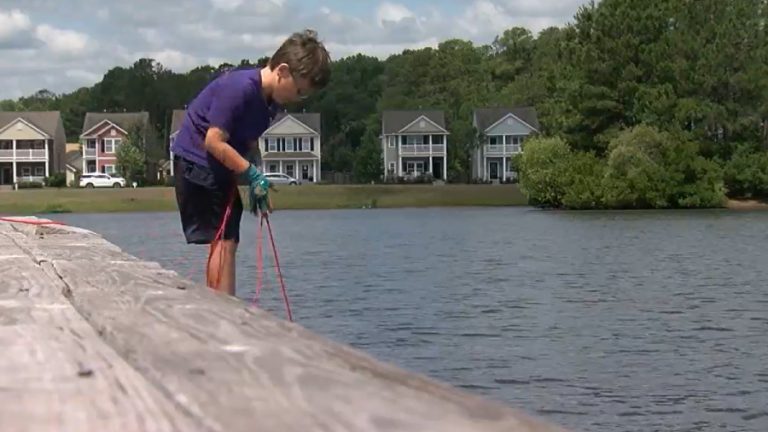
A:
4 219 562 432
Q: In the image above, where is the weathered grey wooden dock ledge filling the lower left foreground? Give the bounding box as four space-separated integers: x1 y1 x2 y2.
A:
0 218 563 432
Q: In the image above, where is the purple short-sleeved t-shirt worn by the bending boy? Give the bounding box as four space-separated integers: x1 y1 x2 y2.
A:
171 68 275 170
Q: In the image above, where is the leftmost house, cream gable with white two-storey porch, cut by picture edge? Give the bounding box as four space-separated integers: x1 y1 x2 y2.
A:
0 111 67 185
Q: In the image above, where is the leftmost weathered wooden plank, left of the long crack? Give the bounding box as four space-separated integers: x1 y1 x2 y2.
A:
0 230 204 431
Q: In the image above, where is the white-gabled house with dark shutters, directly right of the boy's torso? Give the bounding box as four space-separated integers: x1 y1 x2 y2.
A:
259 112 322 183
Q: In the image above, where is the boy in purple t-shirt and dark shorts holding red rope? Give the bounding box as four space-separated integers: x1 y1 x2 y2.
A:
172 30 330 295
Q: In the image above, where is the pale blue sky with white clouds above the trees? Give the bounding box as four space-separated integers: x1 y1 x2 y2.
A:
0 0 586 99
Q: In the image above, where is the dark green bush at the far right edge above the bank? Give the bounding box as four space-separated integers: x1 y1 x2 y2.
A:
723 145 768 198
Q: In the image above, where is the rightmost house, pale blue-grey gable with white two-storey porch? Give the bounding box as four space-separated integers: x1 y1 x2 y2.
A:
472 107 539 182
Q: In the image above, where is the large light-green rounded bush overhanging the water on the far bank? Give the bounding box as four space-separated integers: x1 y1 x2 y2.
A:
520 126 725 209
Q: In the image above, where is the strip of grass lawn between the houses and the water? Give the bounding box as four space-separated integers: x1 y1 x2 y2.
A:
0 185 526 215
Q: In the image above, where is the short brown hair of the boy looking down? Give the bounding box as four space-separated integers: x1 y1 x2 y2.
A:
268 29 331 89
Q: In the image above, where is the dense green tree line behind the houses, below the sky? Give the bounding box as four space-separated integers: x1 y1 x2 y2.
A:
0 0 768 204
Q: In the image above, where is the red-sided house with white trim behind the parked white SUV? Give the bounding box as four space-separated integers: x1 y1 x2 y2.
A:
80 111 149 174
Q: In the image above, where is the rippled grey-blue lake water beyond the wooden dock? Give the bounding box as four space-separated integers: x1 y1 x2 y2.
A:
57 208 768 432
